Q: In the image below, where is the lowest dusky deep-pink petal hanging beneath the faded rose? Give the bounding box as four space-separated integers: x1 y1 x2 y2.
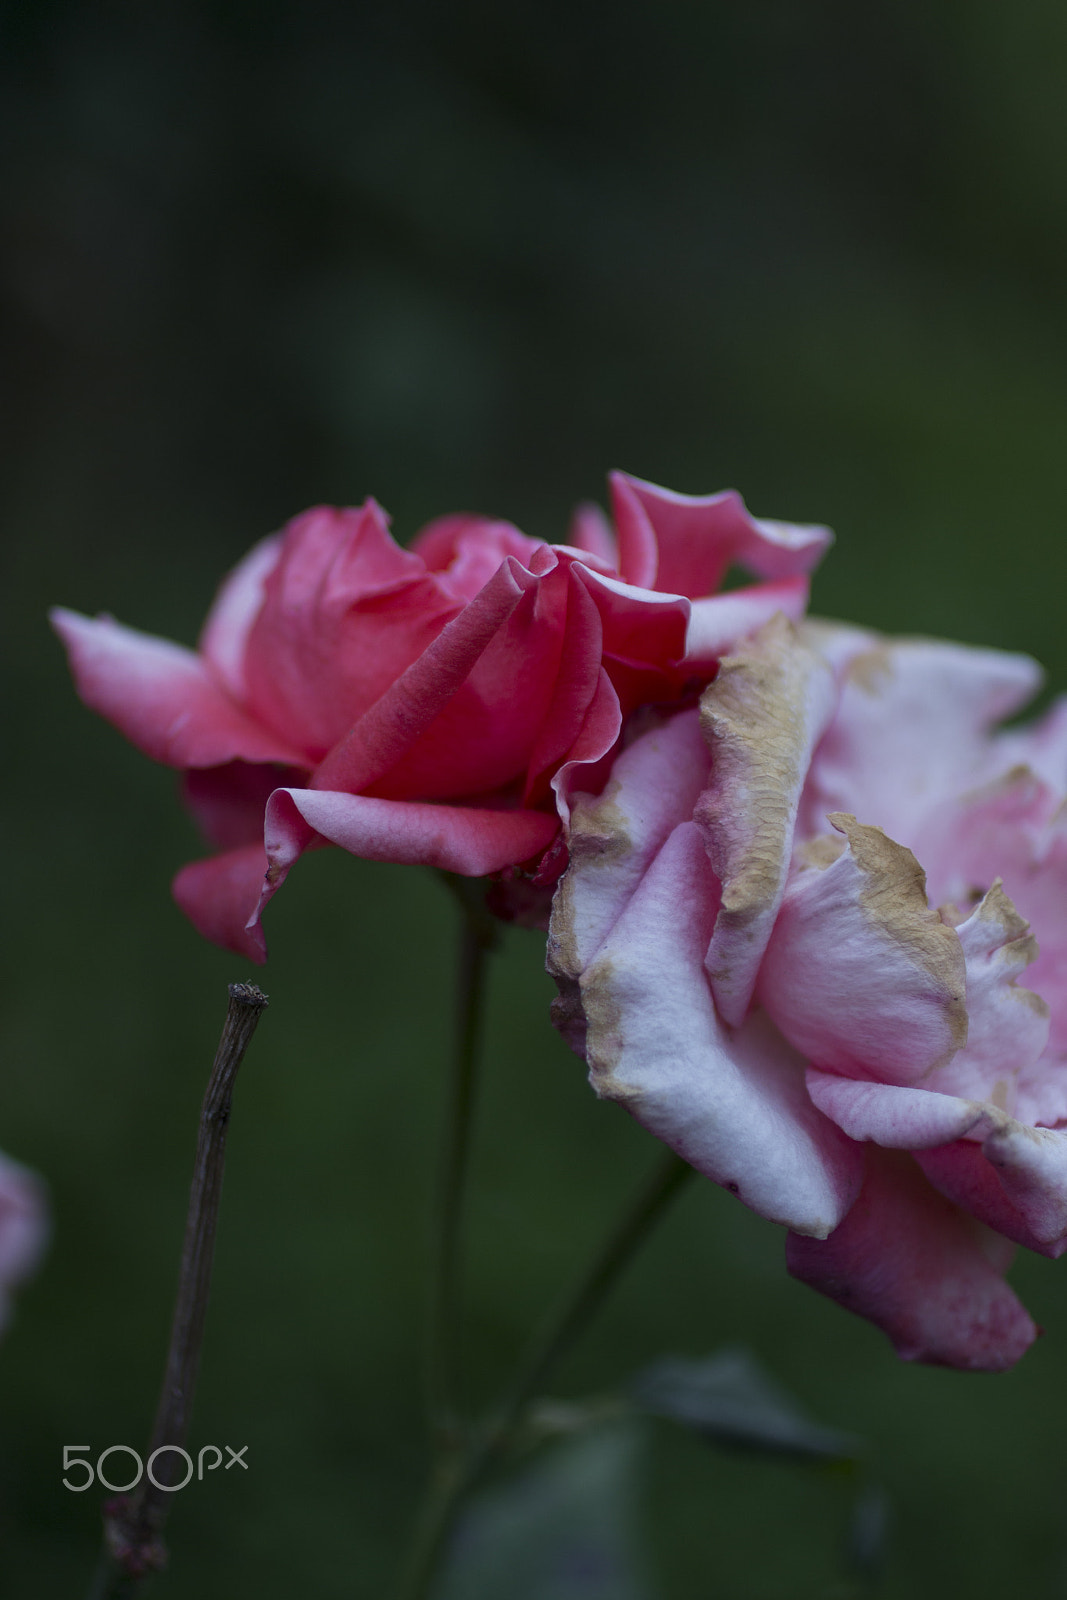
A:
785 1147 1037 1373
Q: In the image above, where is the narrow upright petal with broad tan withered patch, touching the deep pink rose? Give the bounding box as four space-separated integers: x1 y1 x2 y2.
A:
696 616 833 1024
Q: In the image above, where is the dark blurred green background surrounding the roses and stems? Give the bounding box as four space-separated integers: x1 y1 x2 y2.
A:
0 0 1067 1600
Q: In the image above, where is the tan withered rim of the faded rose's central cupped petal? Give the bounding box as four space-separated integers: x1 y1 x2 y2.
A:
827 811 968 1072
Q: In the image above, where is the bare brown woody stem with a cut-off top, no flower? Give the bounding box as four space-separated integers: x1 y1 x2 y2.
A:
90 984 267 1600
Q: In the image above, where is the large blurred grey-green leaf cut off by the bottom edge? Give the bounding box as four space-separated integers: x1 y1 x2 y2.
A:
435 1422 649 1600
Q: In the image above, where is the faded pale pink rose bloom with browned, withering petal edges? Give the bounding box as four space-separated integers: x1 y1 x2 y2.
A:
549 618 1067 1371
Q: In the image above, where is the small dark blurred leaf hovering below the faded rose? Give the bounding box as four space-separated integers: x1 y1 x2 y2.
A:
632 1350 862 1461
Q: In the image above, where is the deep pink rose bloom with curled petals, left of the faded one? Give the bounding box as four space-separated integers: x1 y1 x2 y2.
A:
53 474 830 962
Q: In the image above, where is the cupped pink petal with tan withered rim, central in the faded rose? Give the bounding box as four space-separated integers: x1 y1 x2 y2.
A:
758 813 966 1083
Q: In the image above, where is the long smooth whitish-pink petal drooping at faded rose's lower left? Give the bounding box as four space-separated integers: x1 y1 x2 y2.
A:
557 822 859 1237
